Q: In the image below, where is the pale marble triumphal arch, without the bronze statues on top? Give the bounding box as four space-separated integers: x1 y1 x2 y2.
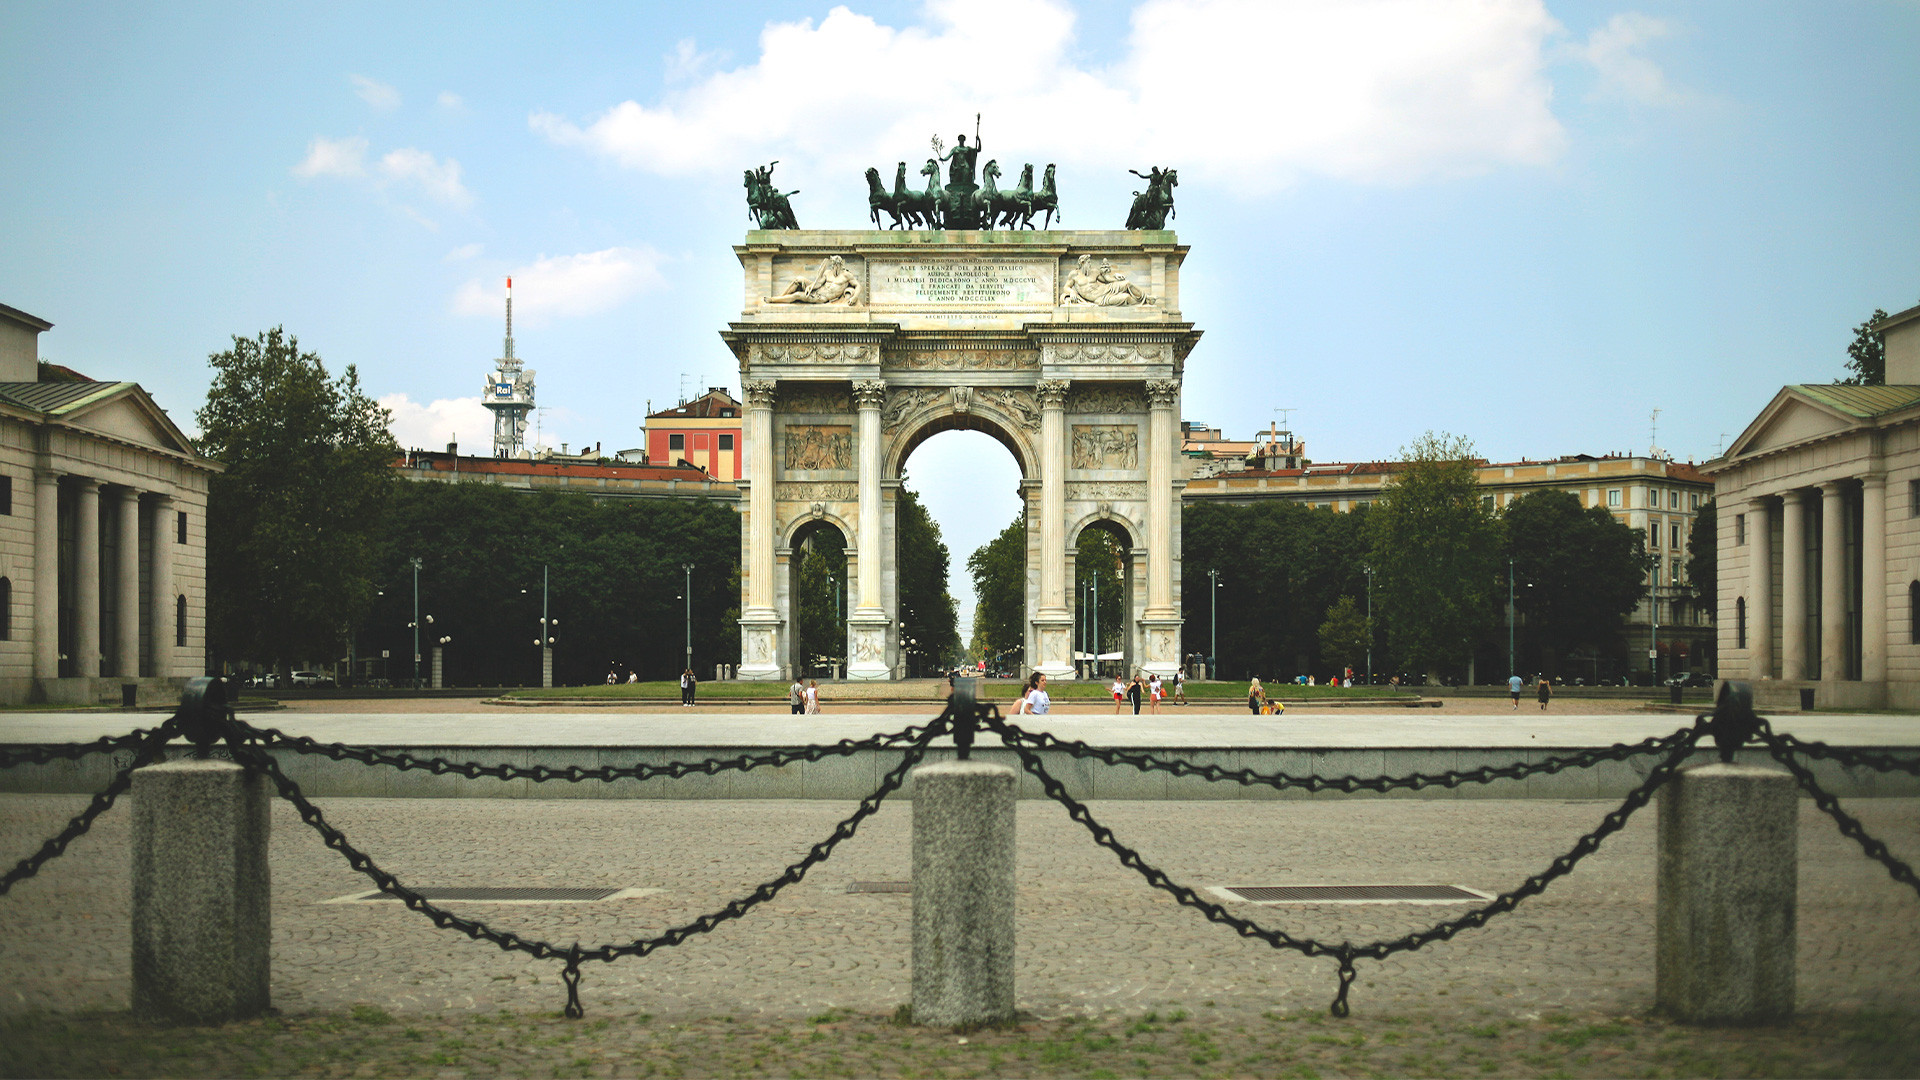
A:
722 229 1200 678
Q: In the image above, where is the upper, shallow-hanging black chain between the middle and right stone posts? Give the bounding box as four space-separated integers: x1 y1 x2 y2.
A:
987 723 1699 794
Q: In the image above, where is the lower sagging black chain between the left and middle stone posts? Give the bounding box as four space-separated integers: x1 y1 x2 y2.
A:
228 723 945 1019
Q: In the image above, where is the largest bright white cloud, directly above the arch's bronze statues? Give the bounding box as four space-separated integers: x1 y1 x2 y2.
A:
528 0 1567 192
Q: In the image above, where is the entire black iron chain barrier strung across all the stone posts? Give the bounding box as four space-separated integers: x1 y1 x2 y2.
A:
0 678 1920 1019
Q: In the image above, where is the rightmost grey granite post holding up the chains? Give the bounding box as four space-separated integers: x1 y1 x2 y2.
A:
1653 763 1799 1024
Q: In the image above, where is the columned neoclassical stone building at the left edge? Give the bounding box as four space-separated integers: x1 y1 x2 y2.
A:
0 304 217 703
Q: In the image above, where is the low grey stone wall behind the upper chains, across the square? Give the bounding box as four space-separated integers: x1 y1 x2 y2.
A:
0 746 1920 799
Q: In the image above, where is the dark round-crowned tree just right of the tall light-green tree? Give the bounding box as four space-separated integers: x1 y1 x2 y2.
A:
1503 488 1653 675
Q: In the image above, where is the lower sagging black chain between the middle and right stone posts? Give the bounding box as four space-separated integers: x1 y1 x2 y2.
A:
987 711 1701 1017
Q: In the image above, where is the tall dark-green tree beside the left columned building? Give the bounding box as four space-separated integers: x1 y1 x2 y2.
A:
196 327 399 673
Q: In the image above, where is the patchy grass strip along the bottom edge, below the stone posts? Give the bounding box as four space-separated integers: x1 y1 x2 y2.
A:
0 1005 1920 1078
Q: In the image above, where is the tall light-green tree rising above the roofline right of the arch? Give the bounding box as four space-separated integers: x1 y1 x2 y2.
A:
1367 432 1501 678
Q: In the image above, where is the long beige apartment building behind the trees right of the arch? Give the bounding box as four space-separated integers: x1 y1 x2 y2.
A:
1185 440 1715 678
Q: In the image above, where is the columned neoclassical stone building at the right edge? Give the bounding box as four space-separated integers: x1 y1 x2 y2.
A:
1701 297 1920 709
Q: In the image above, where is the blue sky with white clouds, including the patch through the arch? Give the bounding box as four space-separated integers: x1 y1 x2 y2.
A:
0 0 1920 638
